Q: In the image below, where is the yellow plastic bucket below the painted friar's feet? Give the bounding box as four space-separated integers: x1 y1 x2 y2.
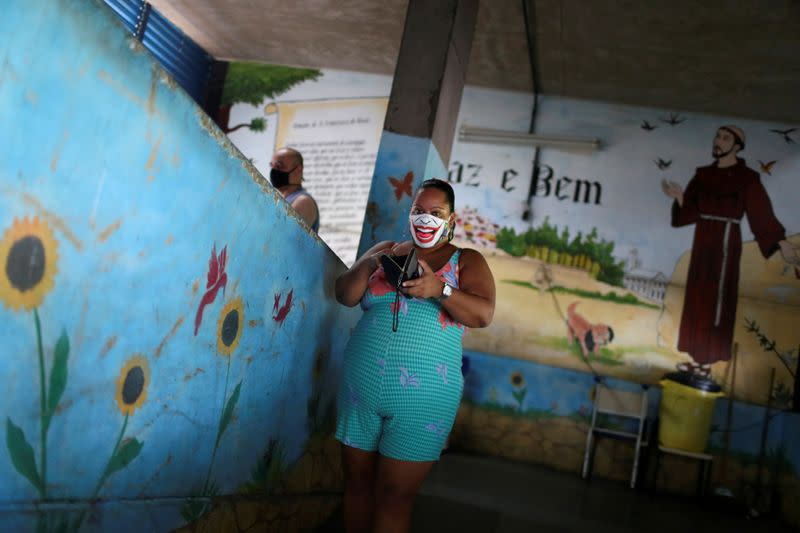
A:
658 379 724 453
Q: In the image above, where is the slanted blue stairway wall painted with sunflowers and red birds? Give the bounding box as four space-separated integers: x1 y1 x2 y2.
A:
0 0 357 531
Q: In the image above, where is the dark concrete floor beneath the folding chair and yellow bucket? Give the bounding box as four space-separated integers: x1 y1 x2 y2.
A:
319 453 792 533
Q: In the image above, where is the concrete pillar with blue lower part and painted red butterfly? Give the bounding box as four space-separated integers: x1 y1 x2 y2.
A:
358 0 478 256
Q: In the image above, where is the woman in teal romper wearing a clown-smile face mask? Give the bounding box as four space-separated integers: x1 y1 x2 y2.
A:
336 179 495 533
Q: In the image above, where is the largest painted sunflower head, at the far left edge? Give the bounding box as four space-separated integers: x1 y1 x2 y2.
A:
0 217 58 310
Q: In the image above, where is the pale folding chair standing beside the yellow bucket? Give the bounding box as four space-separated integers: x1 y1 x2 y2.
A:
581 381 650 488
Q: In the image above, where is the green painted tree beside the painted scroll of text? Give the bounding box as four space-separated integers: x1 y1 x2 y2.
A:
217 62 322 133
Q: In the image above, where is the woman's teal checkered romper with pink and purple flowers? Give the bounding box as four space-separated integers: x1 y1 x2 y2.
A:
336 250 465 461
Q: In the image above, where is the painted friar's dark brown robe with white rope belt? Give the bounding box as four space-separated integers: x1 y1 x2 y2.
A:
672 159 786 364
